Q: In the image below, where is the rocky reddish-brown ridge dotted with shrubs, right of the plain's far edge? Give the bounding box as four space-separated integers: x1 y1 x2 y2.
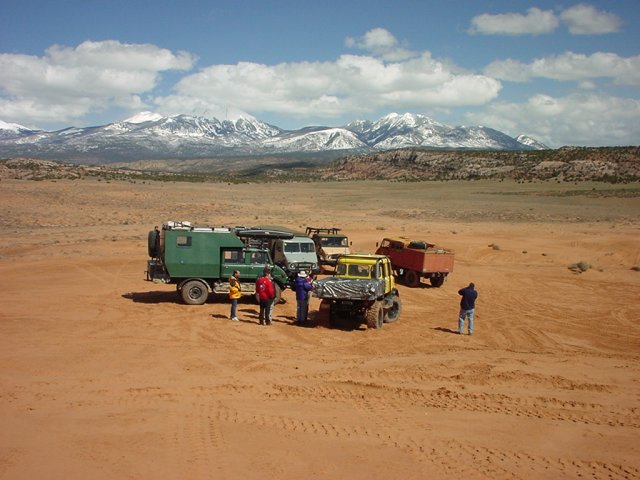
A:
316 147 640 182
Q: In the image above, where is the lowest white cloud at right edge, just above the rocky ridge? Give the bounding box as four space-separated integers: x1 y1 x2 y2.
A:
466 93 640 147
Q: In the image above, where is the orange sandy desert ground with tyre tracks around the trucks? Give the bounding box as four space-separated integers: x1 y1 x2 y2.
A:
0 180 640 479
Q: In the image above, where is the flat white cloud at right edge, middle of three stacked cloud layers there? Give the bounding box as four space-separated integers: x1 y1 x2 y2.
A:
484 52 640 86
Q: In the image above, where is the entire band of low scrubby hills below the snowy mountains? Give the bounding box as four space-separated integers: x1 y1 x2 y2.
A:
0 147 640 183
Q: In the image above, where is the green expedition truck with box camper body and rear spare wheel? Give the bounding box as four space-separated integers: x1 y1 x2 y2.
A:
146 221 289 305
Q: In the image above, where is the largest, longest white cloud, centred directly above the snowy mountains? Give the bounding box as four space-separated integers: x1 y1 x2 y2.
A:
154 52 501 122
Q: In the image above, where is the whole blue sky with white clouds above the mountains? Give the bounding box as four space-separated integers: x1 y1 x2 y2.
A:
0 0 640 147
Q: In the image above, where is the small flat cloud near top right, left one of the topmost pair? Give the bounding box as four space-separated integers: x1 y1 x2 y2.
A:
469 7 560 35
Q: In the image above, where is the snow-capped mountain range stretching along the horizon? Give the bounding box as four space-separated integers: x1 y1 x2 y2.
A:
0 112 548 164
